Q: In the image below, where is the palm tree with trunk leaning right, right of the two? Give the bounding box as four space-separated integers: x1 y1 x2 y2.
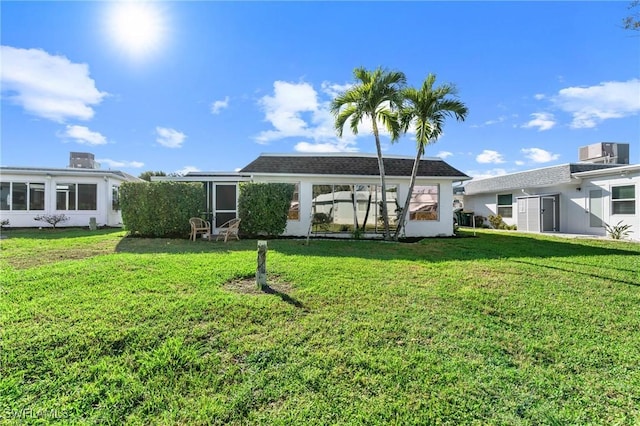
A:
394 74 468 239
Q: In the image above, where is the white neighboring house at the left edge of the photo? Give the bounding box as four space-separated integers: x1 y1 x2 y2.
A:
0 162 139 227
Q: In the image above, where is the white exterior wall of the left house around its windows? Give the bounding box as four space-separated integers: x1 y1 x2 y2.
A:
0 172 123 228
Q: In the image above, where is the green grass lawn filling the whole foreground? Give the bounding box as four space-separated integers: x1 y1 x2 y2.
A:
0 230 640 425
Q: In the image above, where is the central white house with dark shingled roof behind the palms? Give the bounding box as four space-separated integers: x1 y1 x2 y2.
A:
157 154 470 237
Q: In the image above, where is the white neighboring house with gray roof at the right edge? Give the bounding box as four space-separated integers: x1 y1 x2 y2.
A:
464 163 640 240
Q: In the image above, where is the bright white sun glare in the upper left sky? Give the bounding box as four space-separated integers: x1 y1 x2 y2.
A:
108 1 165 59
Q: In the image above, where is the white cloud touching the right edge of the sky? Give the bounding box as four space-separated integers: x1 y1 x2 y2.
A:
553 78 640 129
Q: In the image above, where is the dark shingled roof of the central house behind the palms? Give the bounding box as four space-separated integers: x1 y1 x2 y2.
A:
240 155 469 180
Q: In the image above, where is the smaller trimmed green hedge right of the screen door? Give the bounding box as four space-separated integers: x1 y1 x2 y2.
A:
238 183 295 236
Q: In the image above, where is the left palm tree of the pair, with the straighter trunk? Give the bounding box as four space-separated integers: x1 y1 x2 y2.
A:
331 67 406 239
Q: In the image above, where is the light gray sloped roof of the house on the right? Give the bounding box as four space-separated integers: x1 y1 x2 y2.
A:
464 163 621 195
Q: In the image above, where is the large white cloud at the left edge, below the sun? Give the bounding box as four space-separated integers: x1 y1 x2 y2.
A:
0 46 107 123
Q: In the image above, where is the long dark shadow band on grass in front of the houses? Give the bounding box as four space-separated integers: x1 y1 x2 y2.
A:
116 228 640 266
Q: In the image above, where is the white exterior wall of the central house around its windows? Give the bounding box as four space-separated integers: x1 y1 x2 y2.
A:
253 174 460 237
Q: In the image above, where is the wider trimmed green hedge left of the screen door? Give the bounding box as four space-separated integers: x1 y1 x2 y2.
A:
120 182 205 237
